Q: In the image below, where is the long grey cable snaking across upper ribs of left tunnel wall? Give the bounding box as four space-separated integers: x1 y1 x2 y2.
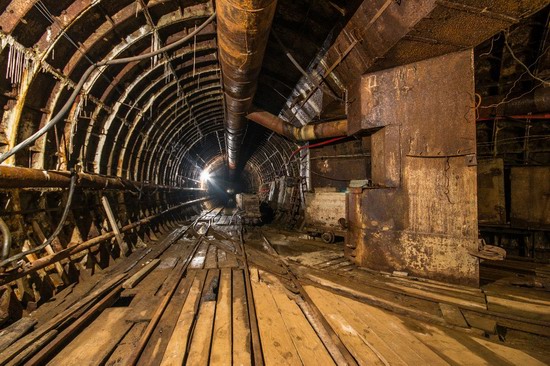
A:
0 12 216 164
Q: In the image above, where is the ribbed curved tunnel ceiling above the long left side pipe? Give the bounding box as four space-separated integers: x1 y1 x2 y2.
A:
0 0 358 192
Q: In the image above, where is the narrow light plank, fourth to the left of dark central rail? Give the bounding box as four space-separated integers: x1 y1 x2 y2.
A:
160 270 206 366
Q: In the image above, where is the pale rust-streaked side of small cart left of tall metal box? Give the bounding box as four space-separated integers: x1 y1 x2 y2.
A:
305 192 346 229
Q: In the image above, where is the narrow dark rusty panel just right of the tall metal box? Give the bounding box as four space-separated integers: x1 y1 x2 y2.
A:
477 159 506 225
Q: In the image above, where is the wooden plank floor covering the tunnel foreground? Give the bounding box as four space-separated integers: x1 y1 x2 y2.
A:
3 217 548 366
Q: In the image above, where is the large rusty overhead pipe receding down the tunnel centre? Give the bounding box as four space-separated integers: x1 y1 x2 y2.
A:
216 0 277 179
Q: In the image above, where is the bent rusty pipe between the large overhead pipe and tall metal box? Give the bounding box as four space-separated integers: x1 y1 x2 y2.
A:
246 110 348 141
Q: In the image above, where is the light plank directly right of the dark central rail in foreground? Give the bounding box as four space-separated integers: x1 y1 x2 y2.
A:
252 281 302 366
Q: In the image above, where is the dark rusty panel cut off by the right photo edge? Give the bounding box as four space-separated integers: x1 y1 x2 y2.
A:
510 166 550 229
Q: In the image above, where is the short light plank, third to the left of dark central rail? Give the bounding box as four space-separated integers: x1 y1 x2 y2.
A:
187 301 216 366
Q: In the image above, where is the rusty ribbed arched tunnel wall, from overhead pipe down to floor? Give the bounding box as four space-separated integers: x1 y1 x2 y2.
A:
0 0 298 322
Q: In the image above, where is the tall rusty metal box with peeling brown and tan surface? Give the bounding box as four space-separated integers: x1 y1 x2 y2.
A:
346 51 479 285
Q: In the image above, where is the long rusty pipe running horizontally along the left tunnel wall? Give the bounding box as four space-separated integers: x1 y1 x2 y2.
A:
0 165 204 191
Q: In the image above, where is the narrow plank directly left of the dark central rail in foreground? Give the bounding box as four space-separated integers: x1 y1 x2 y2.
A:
232 270 252 366
